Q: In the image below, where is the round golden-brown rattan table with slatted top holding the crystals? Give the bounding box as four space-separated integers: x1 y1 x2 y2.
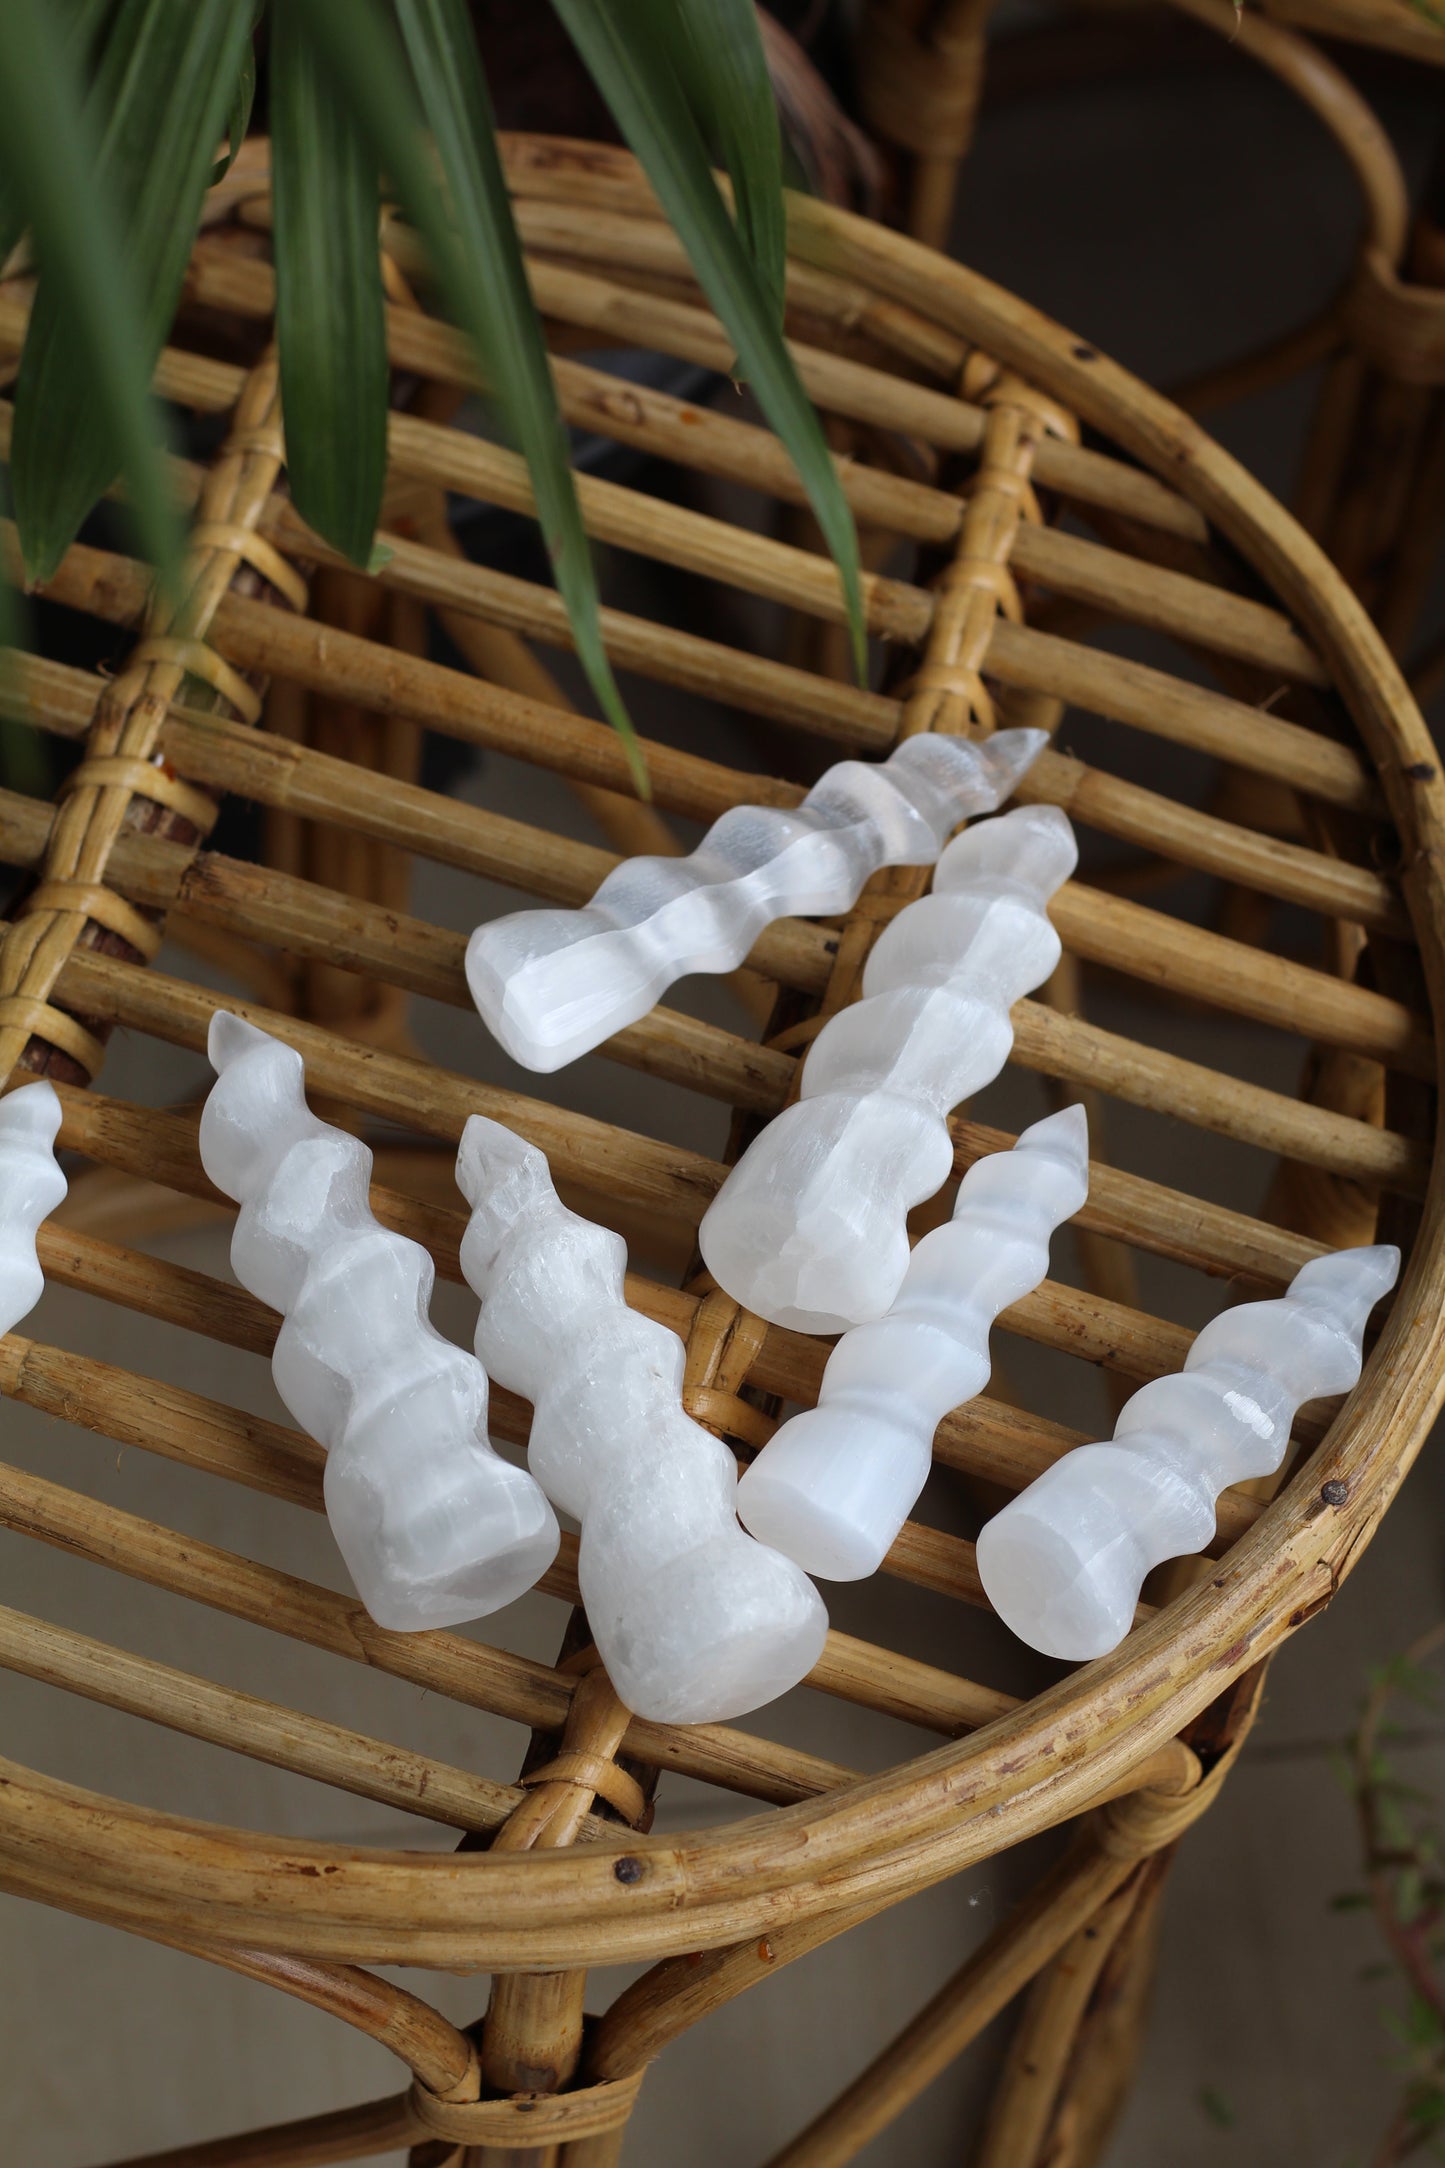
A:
0 139 1445 2168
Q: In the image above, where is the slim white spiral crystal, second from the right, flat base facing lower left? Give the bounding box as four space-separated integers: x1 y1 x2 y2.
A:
737 1106 1090 1580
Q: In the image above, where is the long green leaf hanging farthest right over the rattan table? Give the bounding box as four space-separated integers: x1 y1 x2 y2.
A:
552 0 867 676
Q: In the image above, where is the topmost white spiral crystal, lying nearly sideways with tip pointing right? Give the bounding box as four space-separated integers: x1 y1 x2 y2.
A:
466 731 1046 1069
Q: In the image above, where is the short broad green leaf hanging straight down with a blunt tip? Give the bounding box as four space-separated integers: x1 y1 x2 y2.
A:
271 7 390 566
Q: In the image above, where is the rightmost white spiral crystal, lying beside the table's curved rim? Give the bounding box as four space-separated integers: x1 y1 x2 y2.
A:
979 1244 1400 1661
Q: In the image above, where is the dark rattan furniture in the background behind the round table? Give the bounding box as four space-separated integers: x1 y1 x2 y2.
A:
858 0 1445 700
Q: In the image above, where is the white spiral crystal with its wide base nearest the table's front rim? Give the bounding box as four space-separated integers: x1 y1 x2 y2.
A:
457 1114 828 1724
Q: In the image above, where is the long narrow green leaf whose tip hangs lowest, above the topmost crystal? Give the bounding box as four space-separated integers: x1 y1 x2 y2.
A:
290 0 648 798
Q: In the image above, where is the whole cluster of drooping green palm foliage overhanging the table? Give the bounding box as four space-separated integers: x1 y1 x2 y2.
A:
0 0 867 754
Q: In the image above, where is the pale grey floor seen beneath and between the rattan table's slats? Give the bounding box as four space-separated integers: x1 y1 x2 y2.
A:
0 16 1445 2168
